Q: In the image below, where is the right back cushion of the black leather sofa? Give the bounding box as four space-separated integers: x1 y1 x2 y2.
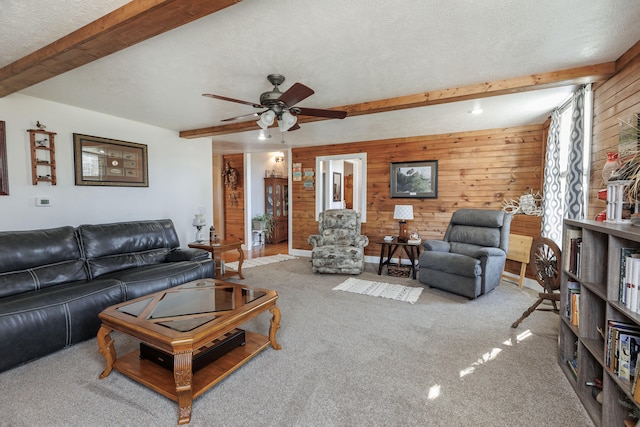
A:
78 219 180 277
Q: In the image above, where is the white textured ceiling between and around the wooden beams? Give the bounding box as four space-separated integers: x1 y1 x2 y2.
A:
0 0 640 153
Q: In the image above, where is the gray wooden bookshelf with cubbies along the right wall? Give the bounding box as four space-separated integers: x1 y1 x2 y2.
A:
558 220 640 427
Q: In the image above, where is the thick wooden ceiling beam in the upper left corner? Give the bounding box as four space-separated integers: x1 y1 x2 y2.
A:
0 0 241 97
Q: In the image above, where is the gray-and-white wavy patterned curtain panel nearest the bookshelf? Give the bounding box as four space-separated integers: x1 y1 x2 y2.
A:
564 87 585 219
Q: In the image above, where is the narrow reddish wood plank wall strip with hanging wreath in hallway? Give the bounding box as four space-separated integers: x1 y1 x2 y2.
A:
222 153 244 241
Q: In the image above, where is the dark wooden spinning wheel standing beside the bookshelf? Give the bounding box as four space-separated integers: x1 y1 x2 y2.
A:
511 237 562 328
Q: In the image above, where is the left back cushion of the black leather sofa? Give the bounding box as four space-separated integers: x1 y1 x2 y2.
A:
0 227 88 298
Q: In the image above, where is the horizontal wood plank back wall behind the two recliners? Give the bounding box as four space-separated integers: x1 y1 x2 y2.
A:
291 124 544 256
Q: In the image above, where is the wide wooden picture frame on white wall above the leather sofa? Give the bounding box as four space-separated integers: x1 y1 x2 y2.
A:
73 133 149 187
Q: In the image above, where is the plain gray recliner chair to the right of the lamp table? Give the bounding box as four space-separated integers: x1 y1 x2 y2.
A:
418 209 513 298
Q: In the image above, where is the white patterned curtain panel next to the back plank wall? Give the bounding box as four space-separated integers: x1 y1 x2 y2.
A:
540 108 563 244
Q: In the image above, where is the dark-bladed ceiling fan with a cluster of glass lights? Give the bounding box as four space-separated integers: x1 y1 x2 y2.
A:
202 74 347 132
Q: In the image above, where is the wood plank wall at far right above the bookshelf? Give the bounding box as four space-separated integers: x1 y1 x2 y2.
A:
587 42 640 218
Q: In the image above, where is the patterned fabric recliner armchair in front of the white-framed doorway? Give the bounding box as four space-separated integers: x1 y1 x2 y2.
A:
307 209 369 274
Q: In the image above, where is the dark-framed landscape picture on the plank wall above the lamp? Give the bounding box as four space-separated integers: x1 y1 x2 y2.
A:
391 160 438 199
